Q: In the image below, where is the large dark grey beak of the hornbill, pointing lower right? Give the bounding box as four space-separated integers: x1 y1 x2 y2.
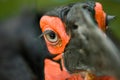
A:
63 5 120 79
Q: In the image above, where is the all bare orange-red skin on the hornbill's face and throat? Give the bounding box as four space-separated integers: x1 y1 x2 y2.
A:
40 2 115 80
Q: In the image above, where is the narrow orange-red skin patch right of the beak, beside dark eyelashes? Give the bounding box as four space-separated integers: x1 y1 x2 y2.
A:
94 2 106 31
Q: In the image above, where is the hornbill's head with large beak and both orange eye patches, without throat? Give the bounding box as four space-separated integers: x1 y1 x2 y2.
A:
40 2 120 80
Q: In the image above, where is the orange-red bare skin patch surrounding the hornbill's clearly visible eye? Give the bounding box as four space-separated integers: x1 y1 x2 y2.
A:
40 16 70 58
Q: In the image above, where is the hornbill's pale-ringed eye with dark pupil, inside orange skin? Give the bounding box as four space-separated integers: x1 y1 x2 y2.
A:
45 30 59 43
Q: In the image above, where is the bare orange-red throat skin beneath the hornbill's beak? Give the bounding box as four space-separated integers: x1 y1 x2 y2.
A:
45 59 116 80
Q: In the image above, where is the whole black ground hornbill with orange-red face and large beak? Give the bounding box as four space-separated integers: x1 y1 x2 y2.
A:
0 2 120 80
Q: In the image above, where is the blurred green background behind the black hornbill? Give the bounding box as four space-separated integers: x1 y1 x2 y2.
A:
0 0 120 40
